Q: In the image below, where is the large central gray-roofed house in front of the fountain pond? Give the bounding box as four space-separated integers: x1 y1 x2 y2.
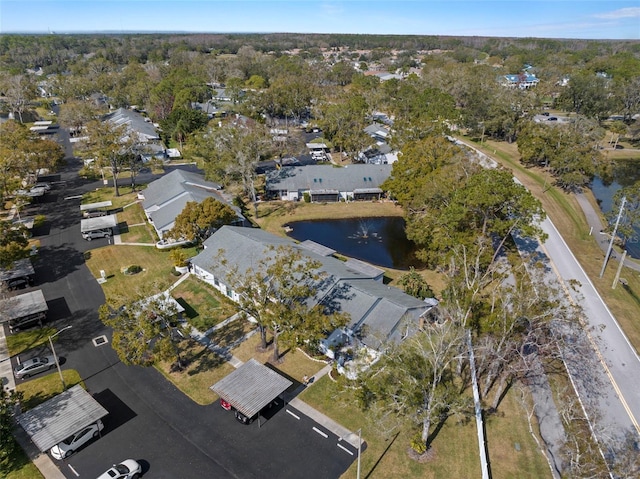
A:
191 226 433 355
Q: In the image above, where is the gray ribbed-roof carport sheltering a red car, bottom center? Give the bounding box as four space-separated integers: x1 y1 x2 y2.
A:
210 359 293 427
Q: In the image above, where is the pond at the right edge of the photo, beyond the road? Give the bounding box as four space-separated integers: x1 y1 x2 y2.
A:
591 160 640 258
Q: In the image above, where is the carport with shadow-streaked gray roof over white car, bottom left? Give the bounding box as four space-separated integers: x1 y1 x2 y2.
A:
18 385 109 452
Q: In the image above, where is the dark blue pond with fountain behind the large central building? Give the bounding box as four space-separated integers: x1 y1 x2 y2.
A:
288 217 415 269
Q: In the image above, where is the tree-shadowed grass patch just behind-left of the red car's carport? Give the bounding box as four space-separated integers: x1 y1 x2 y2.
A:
155 340 234 406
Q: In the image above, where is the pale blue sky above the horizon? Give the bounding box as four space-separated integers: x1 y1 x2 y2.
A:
0 0 640 40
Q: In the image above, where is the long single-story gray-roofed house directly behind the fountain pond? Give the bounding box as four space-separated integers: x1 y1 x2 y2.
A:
266 164 391 202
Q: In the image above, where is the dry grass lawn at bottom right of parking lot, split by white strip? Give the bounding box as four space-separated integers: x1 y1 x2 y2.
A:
300 376 551 479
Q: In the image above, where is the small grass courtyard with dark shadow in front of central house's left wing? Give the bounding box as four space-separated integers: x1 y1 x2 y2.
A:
171 276 238 331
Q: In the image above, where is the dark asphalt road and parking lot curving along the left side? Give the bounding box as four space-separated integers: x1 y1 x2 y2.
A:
13 137 356 479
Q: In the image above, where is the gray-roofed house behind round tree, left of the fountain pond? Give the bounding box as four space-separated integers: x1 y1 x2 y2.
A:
138 170 246 239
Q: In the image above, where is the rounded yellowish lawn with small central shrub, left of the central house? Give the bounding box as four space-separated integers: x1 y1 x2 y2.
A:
86 245 177 301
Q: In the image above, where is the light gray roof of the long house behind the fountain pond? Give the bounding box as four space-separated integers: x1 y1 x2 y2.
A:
266 165 392 192
